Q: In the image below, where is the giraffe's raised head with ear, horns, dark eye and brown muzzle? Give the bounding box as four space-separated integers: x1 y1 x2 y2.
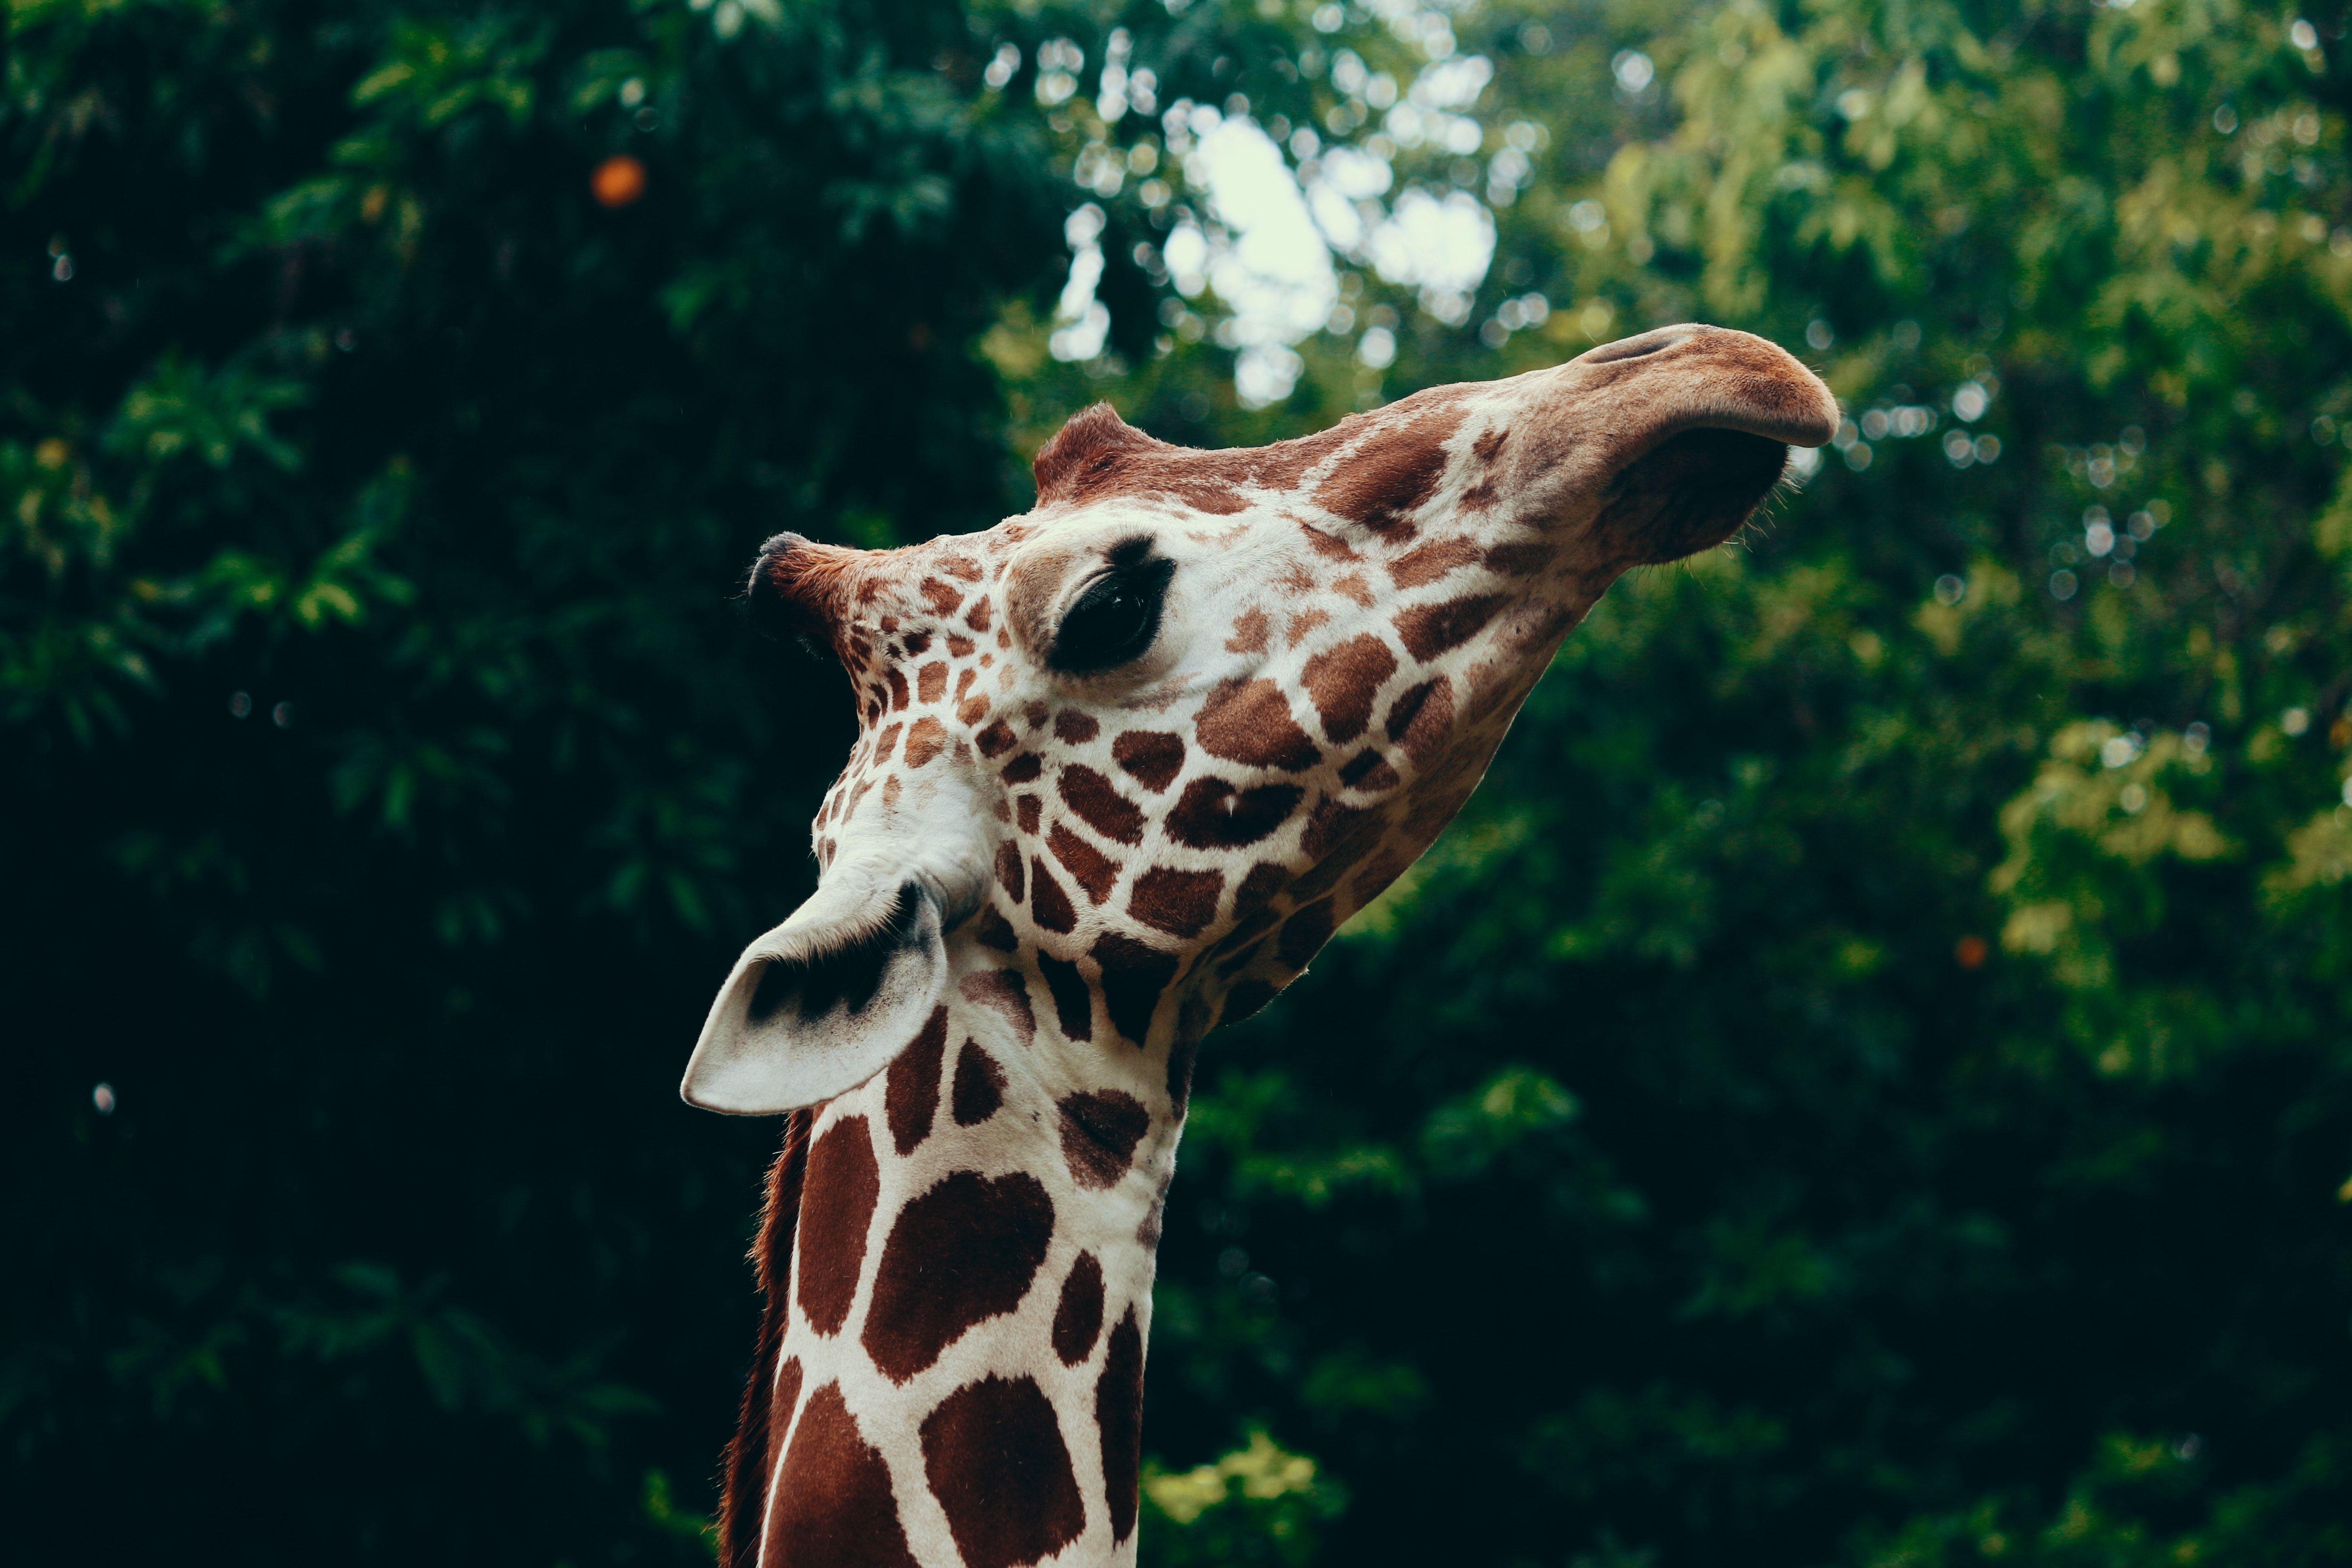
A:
684 327 1839 1117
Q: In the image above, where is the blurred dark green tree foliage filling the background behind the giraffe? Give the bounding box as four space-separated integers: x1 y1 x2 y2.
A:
0 0 2352 1568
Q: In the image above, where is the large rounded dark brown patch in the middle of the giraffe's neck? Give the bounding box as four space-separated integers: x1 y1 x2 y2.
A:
861 1171 1054 1382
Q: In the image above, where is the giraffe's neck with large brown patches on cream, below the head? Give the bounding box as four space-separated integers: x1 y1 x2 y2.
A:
746 940 1181 1568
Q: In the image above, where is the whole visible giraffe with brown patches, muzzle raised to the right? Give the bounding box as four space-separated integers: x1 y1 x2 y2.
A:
682 327 1839 1568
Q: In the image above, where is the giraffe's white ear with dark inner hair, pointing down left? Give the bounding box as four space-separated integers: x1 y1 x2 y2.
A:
677 882 948 1117
